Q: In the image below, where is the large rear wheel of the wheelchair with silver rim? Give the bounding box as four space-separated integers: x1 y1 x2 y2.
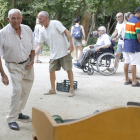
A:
97 53 118 76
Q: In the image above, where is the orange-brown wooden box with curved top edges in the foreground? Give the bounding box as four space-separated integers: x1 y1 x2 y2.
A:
32 106 140 140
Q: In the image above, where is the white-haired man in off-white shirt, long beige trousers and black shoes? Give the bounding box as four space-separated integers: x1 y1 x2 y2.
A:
0 9 35 130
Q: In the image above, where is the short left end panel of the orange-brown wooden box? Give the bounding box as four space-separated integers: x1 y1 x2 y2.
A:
32 108 57 140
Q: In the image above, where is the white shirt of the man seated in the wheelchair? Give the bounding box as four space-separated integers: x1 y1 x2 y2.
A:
96 33 111 46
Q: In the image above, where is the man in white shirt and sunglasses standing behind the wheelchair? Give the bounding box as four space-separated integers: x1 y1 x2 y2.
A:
110 13 124 71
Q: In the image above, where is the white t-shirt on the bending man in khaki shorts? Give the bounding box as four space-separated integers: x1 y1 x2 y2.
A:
38 20 69 59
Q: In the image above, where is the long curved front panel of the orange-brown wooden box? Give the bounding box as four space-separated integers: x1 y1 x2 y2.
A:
55 107 140 140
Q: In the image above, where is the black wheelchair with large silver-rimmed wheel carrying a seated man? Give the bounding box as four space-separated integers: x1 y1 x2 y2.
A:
82 42 118 76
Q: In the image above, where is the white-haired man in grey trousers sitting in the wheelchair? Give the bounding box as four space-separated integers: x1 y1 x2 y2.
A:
74 26 111 68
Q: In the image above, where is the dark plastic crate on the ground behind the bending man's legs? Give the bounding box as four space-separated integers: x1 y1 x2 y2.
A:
56 80 78 92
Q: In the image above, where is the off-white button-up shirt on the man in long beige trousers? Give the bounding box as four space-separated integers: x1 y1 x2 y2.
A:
0 24 35 63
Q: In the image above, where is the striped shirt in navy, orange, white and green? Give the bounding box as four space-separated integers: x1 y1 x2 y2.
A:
123 16 140 53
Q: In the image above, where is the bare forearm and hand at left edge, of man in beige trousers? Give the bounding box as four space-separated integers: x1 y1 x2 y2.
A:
0 57 9 86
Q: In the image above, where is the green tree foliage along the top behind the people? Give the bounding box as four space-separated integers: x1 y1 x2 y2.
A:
0 0 140 35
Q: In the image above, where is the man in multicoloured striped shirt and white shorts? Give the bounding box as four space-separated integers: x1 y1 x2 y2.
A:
123 7 140 87
